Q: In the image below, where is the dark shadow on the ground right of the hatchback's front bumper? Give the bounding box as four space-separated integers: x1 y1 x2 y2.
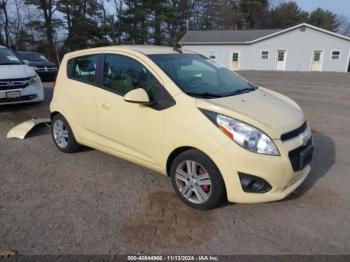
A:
285 131 336 201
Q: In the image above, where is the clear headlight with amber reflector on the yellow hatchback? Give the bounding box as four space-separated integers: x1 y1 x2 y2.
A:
216 114 280 156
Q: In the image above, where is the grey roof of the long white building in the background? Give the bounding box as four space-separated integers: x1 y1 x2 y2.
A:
180 23 350 45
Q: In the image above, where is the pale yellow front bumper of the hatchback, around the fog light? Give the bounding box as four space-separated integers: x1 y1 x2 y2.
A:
213 136 312 203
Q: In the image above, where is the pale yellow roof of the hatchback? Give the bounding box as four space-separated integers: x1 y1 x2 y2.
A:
66 45 195 55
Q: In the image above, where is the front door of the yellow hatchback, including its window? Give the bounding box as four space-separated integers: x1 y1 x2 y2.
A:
98 54 164 166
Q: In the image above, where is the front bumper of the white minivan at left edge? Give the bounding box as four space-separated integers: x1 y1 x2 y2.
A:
0 83 44 105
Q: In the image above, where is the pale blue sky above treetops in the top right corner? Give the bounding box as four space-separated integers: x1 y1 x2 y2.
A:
288 0 350 20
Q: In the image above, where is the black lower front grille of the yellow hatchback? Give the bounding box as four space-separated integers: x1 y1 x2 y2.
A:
288 138 314 172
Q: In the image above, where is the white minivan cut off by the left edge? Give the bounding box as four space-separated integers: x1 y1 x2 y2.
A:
0 46 44 105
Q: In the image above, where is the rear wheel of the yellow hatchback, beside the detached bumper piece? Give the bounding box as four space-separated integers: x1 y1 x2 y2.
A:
51 114 80 153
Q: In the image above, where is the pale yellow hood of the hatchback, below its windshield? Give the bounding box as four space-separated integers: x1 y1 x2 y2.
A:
197 87 305 139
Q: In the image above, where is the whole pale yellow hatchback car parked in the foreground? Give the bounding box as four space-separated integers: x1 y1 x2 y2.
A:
50 46 313 209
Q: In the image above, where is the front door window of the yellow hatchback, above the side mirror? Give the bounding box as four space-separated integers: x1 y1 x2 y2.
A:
103 55 160 101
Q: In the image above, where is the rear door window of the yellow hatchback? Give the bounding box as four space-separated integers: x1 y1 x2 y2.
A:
67 55 98 83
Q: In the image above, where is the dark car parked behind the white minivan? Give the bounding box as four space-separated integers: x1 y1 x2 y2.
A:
17 51 58 82
